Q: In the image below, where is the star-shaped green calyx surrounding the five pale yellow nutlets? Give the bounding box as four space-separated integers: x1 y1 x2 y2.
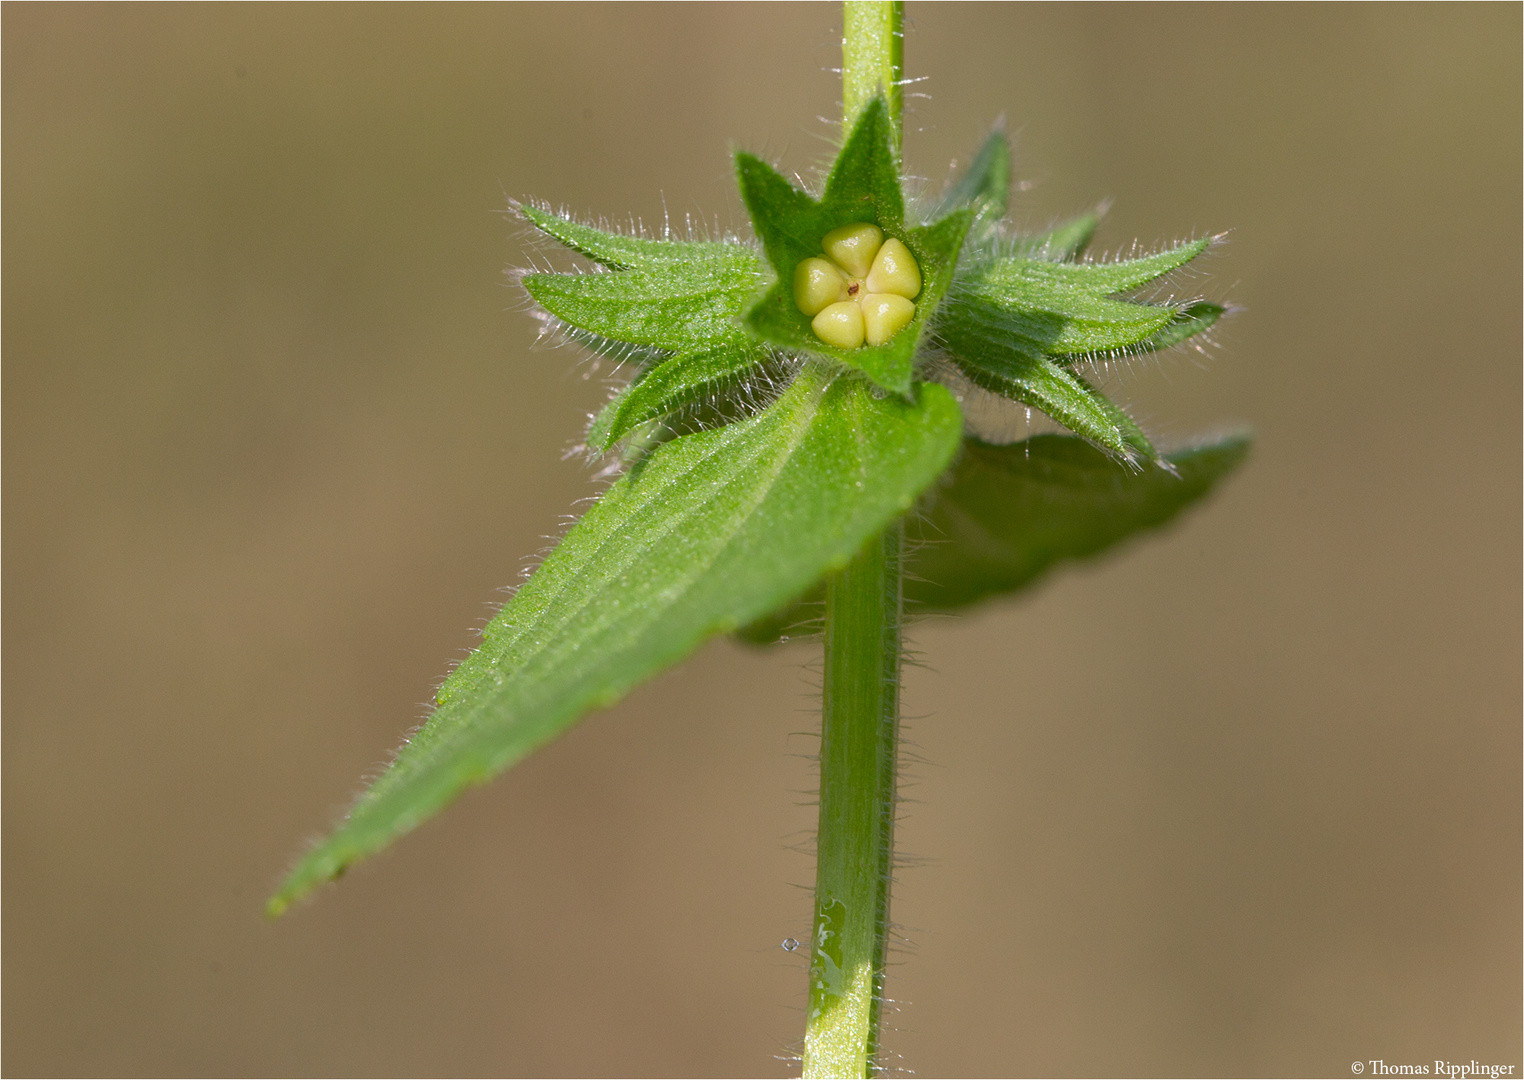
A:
736 97 974 395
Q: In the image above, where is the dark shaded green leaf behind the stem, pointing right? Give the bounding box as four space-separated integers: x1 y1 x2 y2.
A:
736 434 1250 644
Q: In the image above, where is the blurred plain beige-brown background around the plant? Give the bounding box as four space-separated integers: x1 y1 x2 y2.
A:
3 5 1521 1075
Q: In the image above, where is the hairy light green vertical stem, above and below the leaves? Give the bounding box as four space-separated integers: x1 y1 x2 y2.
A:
805 12 905 1077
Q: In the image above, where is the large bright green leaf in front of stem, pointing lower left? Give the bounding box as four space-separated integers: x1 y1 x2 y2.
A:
268 366 962 914
